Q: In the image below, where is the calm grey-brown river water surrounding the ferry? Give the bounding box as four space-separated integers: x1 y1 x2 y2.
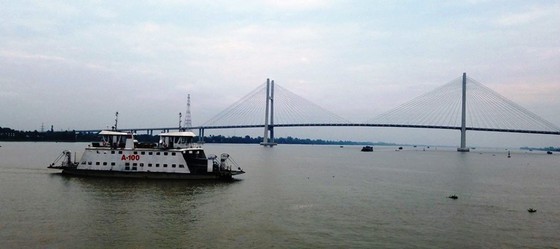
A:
0 142 560 248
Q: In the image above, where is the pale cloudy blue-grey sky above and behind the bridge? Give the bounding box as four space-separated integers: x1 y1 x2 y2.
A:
0 0 560 146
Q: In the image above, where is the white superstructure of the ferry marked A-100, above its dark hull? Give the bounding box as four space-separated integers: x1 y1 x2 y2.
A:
81 131 217 174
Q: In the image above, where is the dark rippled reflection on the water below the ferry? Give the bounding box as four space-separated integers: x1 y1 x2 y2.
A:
53 177 241 247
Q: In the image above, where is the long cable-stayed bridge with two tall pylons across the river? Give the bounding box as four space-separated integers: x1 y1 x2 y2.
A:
76 74 560 151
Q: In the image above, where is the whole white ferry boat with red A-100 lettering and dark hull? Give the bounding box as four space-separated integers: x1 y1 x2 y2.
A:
48 130 245 179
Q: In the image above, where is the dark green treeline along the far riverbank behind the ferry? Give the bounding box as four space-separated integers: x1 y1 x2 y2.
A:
0 127 390 145
